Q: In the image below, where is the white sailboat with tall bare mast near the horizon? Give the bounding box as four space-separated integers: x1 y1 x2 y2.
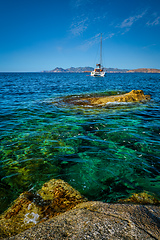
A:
91 33 106 77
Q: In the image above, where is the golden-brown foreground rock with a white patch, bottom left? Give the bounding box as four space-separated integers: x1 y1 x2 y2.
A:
0 179 87 238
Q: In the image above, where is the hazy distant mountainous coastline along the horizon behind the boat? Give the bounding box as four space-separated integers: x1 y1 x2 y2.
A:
42 67 160 73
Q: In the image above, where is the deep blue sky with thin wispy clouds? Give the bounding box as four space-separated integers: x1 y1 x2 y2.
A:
0 0 160 72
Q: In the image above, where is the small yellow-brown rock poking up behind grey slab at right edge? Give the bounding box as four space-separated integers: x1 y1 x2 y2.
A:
119 192 160 205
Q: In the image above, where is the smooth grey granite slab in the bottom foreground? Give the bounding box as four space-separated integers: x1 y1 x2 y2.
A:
4 202 160 240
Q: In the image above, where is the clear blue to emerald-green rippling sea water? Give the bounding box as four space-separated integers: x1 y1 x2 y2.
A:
0 73 160 212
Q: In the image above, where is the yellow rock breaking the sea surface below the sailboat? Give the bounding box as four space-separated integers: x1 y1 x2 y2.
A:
60 90 151 106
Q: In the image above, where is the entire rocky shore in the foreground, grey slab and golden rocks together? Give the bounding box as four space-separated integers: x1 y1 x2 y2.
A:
0 179 160 240
